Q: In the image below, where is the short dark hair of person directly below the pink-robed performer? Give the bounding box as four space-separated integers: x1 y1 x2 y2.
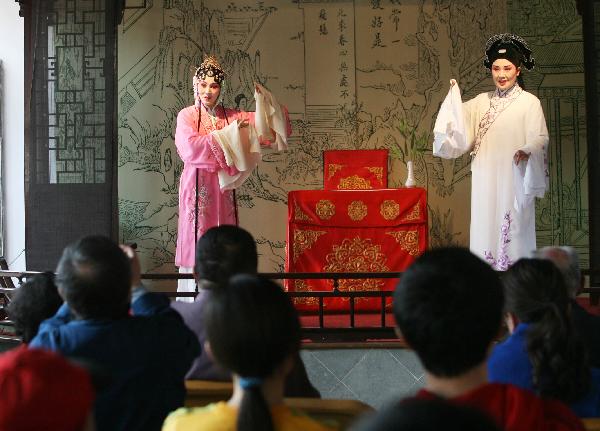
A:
194 225 258 284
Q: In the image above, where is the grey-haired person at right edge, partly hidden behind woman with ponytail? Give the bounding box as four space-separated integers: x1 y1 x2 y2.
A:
534 246 600 368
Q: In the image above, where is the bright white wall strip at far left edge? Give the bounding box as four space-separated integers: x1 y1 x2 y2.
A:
0 1 25 271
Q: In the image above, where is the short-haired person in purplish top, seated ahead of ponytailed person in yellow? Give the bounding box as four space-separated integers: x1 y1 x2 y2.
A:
171 225 320 397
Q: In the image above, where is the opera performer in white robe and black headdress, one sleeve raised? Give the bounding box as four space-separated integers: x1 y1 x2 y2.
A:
433 33 548 271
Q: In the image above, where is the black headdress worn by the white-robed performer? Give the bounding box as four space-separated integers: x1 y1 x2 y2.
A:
483 33 535 70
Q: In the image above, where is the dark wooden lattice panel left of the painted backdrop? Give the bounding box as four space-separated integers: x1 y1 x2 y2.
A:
35 0 107 184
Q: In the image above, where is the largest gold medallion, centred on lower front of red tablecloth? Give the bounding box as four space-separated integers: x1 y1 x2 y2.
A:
323 237 389 300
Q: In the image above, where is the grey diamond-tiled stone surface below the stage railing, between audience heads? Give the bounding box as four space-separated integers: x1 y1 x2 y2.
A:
301 348 424 408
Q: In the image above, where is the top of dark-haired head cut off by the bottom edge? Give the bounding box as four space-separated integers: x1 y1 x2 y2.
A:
352 398 500 431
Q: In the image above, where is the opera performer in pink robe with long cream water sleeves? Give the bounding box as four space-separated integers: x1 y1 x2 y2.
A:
175 57 291 291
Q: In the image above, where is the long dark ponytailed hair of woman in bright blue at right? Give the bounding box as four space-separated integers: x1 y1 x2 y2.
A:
503 259 591 403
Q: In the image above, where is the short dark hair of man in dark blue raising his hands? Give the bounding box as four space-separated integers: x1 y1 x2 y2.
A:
56 236 131 319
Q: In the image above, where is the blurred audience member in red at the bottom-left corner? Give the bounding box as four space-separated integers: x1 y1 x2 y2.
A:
0 346 94 431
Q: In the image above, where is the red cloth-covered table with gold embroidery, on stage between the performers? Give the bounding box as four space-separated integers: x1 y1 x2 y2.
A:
286 188 427 311
